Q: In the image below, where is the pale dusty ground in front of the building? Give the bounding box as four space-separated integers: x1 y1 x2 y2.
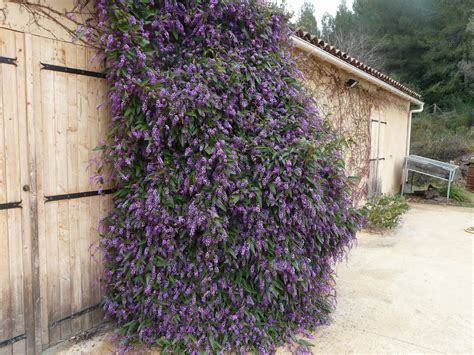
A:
46 204 474 354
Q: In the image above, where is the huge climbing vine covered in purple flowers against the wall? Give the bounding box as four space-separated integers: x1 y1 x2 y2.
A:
88 0 361 353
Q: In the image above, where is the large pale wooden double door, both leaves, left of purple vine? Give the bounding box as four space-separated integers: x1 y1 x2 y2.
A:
0 29 111 355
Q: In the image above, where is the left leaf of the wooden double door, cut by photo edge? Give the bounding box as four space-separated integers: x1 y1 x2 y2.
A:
0 29 34 354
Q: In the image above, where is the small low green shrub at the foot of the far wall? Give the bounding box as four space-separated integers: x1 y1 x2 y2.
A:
365 195 410 229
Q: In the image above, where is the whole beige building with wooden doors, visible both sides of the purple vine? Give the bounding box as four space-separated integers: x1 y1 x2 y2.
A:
0 0 423 354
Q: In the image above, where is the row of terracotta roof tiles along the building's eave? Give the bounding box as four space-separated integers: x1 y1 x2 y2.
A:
294 29 421 100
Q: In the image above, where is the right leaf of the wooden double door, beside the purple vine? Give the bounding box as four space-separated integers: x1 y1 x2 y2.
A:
32 36 111 348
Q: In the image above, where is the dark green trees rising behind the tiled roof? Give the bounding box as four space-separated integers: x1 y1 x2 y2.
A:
294 0 474 109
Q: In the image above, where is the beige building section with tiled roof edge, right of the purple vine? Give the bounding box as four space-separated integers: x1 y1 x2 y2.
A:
291 30 423 200
